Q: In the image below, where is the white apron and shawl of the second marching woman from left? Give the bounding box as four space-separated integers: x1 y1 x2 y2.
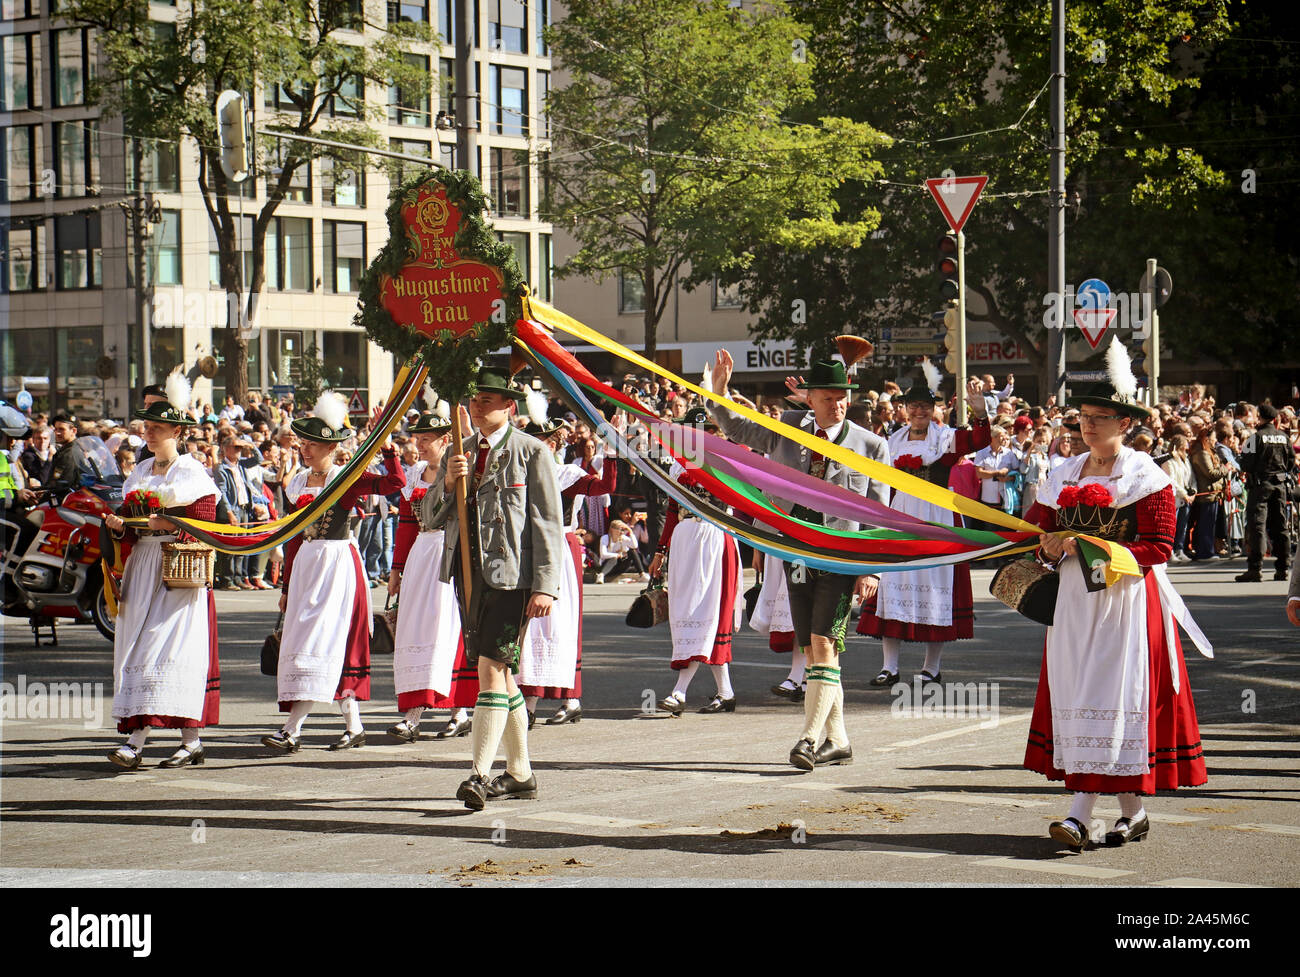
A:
276 469 374 703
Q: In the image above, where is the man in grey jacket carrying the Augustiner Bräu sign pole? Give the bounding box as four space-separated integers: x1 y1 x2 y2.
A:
421 368 559 811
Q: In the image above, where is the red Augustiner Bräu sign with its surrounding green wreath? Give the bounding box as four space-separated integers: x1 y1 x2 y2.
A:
352 168 528 403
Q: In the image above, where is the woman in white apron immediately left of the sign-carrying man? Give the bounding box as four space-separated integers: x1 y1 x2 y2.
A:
389 413 463 743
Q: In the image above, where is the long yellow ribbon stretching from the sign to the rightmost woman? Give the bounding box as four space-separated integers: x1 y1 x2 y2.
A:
524 298 1141 576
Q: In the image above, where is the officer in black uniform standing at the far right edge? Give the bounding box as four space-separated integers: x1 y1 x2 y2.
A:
1236 404 1296 583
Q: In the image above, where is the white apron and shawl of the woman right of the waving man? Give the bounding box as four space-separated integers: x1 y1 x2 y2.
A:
876 424 957 628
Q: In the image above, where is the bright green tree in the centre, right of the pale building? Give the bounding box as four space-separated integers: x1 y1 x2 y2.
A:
543 0 888 357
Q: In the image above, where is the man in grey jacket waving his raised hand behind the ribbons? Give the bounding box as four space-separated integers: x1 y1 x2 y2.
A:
711 349 889 770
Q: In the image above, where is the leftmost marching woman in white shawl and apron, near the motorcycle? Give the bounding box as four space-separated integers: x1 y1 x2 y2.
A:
104 373 221 770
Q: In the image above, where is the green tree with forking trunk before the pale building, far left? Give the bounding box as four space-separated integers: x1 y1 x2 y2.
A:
60 0 432 403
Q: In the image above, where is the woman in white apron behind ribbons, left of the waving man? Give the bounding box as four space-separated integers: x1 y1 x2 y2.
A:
650 408 740 716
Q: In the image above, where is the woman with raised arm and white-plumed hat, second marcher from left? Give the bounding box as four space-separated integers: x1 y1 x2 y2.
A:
261 391 406 754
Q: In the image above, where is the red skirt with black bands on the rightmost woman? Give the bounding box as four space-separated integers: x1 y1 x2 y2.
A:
1024 573 1206 795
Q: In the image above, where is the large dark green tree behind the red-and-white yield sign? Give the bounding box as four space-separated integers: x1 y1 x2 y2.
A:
732 0 1253 390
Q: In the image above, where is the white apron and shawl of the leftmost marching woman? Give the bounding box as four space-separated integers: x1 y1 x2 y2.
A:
113 455 218 720
